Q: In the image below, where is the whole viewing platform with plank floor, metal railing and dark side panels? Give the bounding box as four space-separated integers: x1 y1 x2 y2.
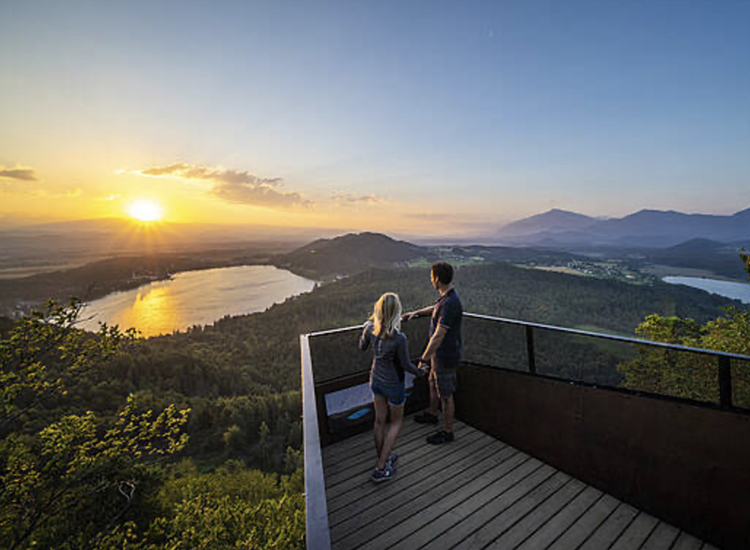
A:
300 313 750 550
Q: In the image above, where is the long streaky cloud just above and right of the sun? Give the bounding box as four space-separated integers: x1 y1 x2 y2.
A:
139 162 312 208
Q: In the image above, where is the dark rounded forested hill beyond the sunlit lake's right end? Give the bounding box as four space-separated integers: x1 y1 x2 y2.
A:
273 233 429 277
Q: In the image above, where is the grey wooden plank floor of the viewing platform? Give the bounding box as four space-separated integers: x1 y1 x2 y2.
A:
323 418 714 550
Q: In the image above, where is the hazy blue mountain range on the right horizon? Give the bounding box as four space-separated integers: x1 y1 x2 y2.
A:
499 208 750 248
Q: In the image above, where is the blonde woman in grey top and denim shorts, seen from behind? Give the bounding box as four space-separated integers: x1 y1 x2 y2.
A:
359 292 424 483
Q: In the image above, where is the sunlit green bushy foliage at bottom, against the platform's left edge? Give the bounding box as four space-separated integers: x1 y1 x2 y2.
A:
90 459 305 550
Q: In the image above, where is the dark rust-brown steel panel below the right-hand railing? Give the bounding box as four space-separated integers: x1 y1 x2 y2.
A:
456 365 750 549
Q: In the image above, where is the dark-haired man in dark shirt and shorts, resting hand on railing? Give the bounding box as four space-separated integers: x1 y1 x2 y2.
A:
404 262 463 445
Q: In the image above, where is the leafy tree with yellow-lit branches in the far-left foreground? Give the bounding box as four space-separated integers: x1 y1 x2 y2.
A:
0 300 189 549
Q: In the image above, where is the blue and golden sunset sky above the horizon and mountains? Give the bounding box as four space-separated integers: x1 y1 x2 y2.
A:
0 0 750 234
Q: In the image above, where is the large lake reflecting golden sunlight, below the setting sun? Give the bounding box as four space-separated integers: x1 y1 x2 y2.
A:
80 265 315 336
